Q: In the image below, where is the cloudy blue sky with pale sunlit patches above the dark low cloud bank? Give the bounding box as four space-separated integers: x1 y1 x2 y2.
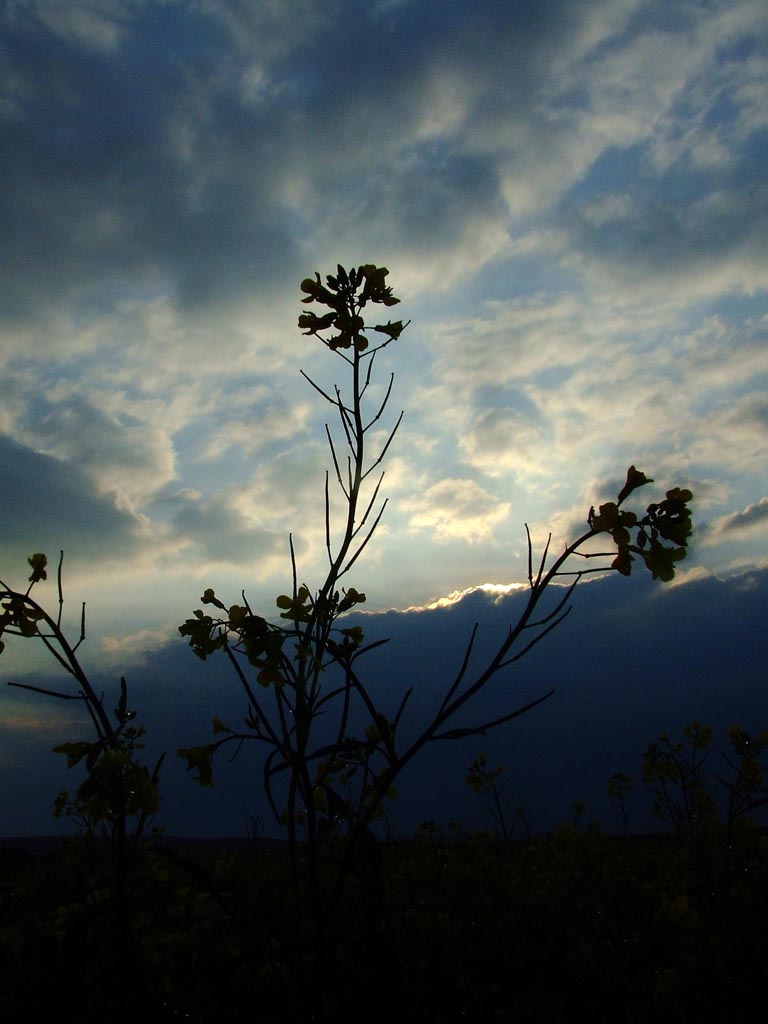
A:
0 0 768 830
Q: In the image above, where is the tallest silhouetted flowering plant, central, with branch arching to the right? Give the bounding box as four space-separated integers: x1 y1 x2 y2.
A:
179 265 692 929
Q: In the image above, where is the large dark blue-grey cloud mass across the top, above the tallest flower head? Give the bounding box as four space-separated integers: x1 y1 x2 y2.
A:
0 0 758 331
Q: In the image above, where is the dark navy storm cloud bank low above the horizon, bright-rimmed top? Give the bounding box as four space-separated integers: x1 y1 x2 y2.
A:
3 570 768 835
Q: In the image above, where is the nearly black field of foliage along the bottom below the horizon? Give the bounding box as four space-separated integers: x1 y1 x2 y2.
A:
0 824 768 1024
